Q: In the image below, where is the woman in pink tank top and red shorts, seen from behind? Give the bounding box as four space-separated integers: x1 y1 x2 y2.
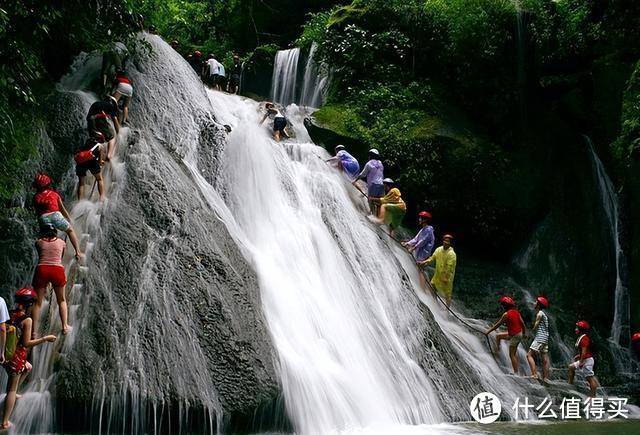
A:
31 224 69 337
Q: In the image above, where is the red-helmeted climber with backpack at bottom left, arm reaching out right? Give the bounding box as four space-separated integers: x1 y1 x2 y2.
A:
1 287 57 429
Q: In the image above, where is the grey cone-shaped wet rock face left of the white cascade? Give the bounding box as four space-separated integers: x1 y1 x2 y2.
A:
42 37 279 431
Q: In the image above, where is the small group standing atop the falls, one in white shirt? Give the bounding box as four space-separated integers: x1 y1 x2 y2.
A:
185 47 244 94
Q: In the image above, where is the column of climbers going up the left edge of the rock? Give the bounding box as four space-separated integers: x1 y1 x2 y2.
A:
0 43 133 429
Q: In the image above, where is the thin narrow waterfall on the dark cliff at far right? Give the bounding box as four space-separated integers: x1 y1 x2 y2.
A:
585 136 630 352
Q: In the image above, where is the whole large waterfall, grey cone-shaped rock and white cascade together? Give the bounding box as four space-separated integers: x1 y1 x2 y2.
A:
7 35 604 434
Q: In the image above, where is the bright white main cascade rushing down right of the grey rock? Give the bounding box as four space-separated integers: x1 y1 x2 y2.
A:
203 86 544 433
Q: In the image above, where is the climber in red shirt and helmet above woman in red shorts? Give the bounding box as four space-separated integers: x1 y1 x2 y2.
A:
32 173 84 261
